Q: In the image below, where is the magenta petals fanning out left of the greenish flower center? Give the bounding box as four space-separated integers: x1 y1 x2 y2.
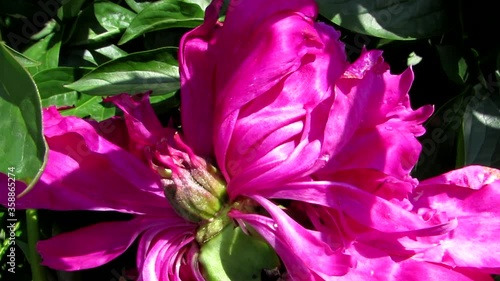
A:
1 101 202 280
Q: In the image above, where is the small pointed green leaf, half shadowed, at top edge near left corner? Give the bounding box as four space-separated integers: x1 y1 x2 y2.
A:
69 2 136 45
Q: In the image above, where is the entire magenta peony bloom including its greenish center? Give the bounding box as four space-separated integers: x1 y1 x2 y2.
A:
0 0 498 280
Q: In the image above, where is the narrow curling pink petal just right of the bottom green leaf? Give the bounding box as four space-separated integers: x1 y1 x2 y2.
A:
232 196 352 280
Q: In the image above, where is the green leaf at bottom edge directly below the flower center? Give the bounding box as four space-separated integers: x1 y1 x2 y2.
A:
199 225 279 281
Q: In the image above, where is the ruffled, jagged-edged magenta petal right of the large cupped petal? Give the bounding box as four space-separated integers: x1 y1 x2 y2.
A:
318 51 433 180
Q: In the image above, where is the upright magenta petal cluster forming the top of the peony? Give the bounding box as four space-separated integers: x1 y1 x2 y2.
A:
180 0 432 199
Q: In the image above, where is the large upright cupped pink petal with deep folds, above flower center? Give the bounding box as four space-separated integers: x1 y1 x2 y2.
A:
215 22 347 197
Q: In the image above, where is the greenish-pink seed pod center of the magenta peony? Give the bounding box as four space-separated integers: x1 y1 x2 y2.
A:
149 134 231 244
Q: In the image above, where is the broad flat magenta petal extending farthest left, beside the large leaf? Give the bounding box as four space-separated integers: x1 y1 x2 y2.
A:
0 108 168 213
